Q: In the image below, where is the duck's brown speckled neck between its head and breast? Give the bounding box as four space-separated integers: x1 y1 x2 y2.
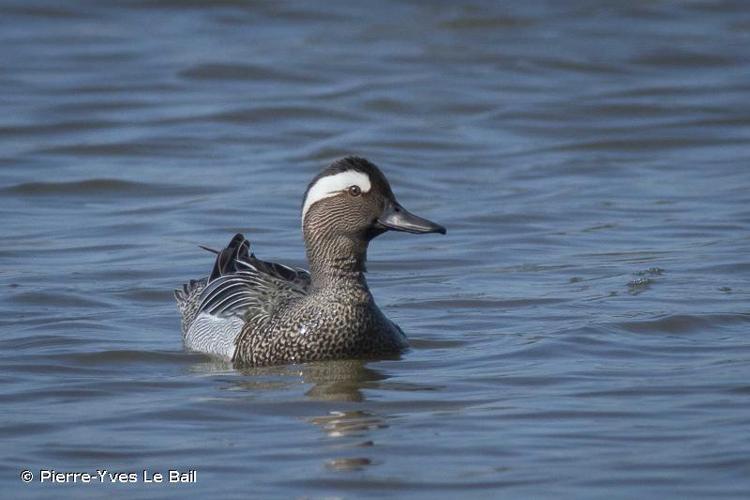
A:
305 236 369 293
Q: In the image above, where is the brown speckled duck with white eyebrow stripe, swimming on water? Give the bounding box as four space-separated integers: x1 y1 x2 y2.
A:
174 156 446 368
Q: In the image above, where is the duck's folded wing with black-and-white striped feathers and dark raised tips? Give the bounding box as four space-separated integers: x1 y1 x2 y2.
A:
197 234 310 323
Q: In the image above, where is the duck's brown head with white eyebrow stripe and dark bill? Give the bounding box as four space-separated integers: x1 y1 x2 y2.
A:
302 156 445 274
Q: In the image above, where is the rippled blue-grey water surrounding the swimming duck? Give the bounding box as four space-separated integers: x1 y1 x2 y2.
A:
0 0 750 499
